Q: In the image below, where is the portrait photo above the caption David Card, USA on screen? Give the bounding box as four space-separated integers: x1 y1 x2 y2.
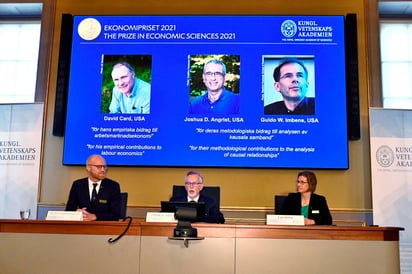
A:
101 55 151 114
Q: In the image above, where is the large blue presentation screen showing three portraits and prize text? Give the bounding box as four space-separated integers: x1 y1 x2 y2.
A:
63 15 348 169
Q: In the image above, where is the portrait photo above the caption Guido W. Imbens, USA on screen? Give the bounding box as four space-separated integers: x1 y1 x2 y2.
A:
264 57 315 115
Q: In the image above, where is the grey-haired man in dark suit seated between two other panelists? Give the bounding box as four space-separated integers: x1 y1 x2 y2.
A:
170 170 225 224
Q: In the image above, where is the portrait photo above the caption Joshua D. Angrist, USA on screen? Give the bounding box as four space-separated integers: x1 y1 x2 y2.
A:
189 55 240 115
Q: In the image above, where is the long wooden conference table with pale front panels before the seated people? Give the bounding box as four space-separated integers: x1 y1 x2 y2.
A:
0 219 403 274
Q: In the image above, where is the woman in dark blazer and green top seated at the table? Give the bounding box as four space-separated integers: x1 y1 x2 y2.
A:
281 171 332 225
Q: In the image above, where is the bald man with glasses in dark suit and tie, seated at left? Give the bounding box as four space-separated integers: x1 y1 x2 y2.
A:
66 155 121 221
